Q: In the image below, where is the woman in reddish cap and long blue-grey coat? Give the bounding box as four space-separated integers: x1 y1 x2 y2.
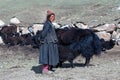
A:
39 10 59 73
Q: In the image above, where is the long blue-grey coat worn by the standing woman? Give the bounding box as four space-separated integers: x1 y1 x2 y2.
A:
39 21 59 66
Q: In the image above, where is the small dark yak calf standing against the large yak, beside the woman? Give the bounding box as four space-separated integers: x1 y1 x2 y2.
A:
56 45 80 68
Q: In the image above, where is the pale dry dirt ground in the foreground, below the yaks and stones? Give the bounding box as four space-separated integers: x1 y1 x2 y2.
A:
0 45 120 80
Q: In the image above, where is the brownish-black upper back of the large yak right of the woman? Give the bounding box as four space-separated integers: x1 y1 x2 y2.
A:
56 28 94 45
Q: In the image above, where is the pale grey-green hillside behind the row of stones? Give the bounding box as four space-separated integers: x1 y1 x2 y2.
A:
0 0 120 26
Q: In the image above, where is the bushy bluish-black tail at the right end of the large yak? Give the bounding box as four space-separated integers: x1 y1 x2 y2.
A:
93 33 102 55
